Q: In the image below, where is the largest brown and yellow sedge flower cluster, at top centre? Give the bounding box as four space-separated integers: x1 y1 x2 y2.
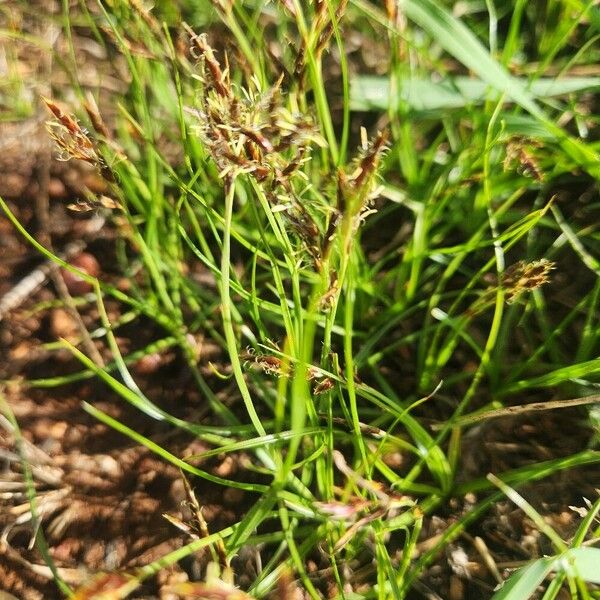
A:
188 30 325 263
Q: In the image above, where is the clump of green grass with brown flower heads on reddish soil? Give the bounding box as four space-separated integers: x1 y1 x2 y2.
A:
3 0 600 598
